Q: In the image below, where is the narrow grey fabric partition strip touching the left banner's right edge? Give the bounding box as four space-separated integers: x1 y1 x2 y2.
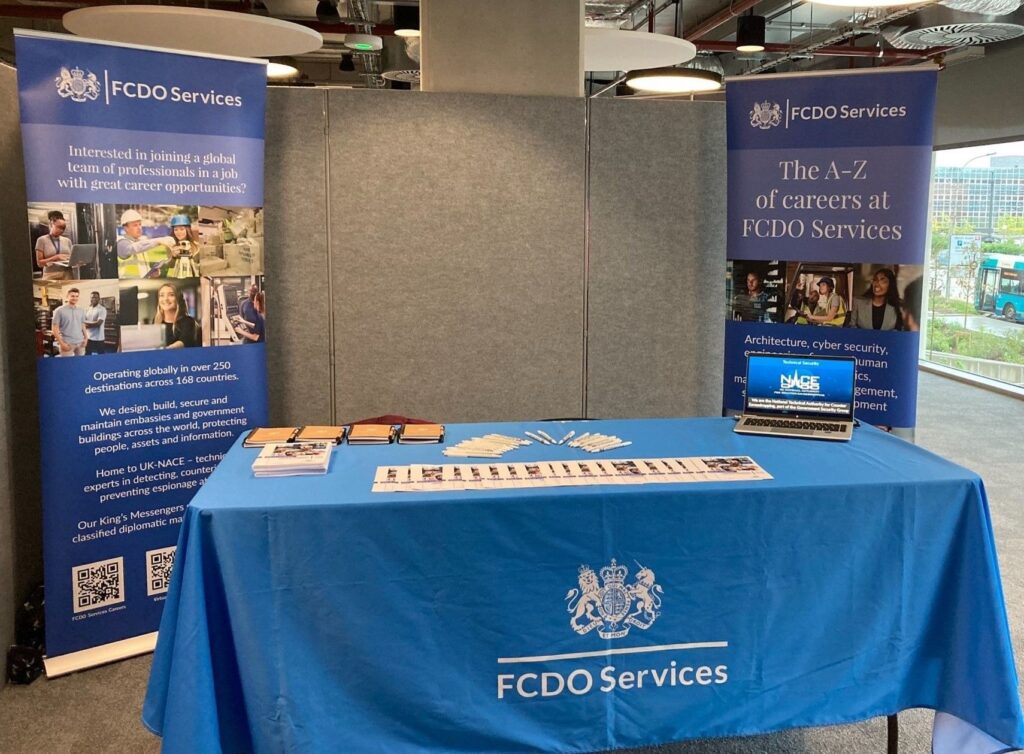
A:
264 87 333 424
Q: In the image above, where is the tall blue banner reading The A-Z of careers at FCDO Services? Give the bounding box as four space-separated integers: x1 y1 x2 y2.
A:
724 69 937 433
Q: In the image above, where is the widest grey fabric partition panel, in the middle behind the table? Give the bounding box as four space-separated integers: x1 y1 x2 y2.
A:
325 89 586 421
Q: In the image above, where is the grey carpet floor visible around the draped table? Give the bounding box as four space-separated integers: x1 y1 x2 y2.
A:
0 373 1024 754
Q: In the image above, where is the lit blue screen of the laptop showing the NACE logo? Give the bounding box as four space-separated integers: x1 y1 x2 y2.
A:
744 353 857 421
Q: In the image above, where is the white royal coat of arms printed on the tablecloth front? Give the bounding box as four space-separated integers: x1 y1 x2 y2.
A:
565 558 664 639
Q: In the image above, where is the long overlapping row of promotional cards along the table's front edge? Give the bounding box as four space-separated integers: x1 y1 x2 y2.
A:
373 456 772 492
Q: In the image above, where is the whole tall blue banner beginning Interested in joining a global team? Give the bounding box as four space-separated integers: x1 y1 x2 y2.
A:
15 31 267 675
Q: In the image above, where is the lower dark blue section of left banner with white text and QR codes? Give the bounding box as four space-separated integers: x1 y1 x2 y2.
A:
39 345 266 654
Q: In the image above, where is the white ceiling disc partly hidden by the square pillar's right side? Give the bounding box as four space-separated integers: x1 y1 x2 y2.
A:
583 27 697 71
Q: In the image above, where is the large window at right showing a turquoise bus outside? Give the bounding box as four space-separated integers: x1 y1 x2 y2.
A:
922 141 1024 388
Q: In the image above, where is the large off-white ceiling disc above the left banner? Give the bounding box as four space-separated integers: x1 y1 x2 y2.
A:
63 5 324 57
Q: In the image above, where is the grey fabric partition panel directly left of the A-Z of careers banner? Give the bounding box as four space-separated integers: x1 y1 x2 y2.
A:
587 98 726 417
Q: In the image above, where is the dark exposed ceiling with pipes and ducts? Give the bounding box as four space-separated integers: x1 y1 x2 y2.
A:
0 0 1024 88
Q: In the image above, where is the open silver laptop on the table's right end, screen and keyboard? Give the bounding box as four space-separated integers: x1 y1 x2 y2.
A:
734 353 857 439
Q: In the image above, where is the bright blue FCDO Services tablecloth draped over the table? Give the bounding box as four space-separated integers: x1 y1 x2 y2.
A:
143 419 1024 753
